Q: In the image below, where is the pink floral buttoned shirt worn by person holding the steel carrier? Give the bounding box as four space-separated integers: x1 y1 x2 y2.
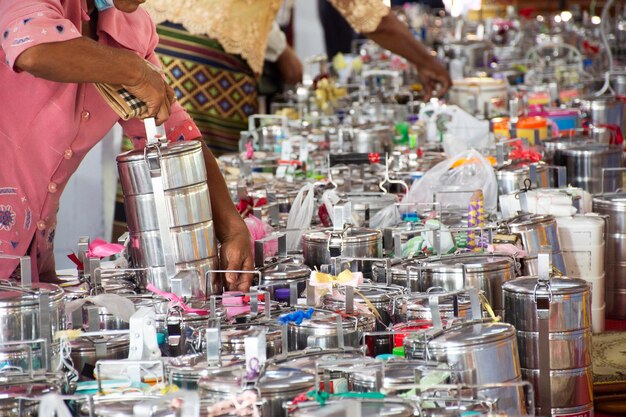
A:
0 0 200 280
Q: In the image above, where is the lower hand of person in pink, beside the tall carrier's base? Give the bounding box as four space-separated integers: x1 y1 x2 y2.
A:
220 228 254 292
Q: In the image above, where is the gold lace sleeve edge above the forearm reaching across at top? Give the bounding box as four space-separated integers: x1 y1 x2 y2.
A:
328 0 390 33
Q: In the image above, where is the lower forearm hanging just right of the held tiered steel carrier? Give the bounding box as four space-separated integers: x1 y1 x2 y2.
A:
202 143 248 242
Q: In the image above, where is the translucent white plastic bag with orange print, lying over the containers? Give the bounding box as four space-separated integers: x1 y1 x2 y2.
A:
404 149 498 213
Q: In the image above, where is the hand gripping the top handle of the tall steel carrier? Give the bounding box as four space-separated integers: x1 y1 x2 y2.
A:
122 60 176 125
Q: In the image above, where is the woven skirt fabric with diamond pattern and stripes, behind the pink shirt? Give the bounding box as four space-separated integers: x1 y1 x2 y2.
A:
156 23 257 155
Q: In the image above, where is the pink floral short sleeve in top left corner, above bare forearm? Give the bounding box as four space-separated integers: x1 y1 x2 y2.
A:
0 0 81 72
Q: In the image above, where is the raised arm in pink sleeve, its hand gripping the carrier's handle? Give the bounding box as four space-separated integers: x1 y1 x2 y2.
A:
0 0 173 121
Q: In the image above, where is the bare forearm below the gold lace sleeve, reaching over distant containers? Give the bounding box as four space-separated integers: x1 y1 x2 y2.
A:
364 13 433 67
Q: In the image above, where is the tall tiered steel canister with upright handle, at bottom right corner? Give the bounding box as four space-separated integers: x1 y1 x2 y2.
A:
504 259 593 416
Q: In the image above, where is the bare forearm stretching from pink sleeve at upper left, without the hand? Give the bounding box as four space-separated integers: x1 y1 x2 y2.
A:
16 37 143 84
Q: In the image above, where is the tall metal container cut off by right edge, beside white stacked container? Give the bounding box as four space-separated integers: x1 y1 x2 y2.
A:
593 193 626 319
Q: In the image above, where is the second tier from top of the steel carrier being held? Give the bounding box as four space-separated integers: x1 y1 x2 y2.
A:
124 182 213 232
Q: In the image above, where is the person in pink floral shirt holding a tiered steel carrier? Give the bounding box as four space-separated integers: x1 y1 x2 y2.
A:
0 0 253 290
